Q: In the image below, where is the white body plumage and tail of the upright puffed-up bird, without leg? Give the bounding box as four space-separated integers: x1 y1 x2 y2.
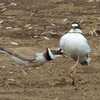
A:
60 24 91 64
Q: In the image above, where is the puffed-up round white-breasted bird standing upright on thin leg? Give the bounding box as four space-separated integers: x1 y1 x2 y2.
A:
59 22 91 85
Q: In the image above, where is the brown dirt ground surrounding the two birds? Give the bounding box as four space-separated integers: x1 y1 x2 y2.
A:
0 0 100 100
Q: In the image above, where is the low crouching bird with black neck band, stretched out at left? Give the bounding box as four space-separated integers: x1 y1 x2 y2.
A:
0 47 61 65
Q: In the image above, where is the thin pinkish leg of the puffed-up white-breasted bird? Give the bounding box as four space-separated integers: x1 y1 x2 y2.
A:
69 56 79 85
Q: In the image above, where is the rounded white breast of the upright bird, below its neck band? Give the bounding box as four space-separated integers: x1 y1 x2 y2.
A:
60 33 90 56
